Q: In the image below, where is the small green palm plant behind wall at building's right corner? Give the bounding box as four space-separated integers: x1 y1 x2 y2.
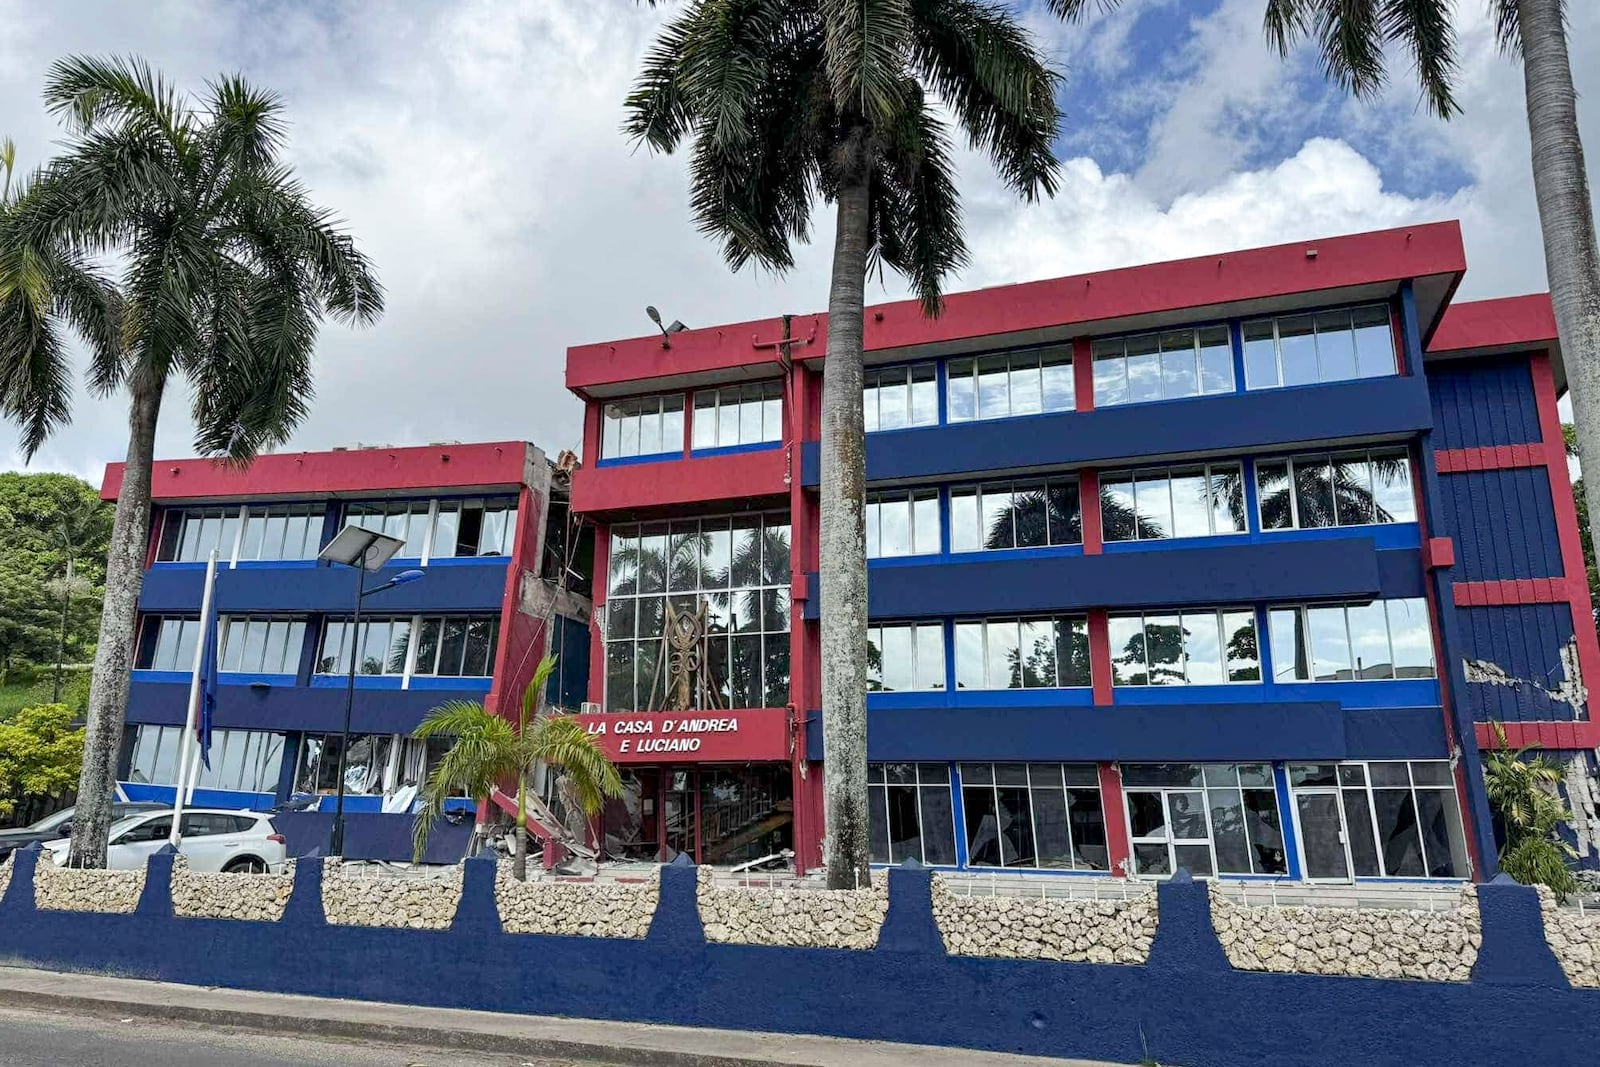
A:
1483 723 1578 901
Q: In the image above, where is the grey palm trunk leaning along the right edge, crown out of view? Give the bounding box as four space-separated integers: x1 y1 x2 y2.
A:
1517 0 1600 579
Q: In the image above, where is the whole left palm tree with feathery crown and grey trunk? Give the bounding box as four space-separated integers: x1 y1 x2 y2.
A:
0 58 382 867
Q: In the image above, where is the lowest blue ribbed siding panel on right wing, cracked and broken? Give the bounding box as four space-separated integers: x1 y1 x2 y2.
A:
1456 603 1573 723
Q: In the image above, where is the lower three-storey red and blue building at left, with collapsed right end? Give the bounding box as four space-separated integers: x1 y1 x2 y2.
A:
101 442 590 859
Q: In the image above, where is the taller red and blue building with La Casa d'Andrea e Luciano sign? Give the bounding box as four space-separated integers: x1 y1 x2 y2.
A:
566 222 1600 881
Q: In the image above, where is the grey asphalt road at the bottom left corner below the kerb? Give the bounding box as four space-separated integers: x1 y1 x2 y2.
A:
0 1008 604 1067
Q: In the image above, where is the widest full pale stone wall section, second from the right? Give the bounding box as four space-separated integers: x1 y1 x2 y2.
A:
1211 885 1483 982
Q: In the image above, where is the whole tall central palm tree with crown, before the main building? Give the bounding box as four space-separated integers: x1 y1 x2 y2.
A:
626 0 1083 888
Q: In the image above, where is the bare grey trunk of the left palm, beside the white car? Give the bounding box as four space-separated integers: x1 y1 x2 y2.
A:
70 378 165 867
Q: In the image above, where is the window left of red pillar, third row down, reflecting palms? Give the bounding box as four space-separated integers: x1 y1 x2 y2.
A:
955 616 1090 689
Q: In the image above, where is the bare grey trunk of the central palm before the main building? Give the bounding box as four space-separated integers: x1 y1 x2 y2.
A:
819 156 872 889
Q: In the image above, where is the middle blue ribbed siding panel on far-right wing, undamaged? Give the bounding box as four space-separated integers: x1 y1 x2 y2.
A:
1435 467 1563 582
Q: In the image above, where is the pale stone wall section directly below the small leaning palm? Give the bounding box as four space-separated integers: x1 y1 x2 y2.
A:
494 864 661 941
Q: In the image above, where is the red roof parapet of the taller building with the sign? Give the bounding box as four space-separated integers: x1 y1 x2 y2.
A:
566 221 1467 395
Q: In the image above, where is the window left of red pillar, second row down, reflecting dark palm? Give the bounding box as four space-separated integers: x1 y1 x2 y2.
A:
950 478 1083 552
